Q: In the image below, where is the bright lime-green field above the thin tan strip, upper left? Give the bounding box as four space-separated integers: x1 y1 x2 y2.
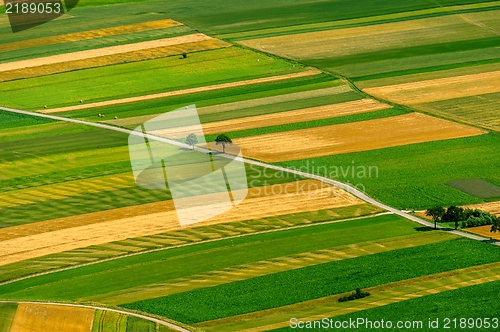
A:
0 47 298 109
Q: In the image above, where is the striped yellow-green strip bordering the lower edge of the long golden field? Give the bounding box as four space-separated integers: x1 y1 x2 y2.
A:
0 204 380 281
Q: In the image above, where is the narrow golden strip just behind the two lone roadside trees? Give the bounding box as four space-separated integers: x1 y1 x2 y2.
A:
153 99 391 138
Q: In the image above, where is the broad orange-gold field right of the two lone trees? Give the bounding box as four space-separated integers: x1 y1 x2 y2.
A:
234 113 486 162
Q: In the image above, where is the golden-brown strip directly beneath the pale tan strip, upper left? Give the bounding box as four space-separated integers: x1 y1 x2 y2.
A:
0 38 231 82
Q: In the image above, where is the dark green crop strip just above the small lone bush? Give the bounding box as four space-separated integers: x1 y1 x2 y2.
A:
123 238 500 323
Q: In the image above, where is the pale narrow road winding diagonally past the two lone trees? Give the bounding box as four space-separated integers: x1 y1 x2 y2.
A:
0 107 500 246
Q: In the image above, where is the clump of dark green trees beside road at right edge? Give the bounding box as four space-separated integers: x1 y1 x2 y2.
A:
425 206 500 232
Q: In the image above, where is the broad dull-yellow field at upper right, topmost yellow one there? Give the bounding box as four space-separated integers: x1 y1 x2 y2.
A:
239 11 498 59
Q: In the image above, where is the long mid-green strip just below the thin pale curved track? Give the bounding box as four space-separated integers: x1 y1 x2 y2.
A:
0 216 420 301
